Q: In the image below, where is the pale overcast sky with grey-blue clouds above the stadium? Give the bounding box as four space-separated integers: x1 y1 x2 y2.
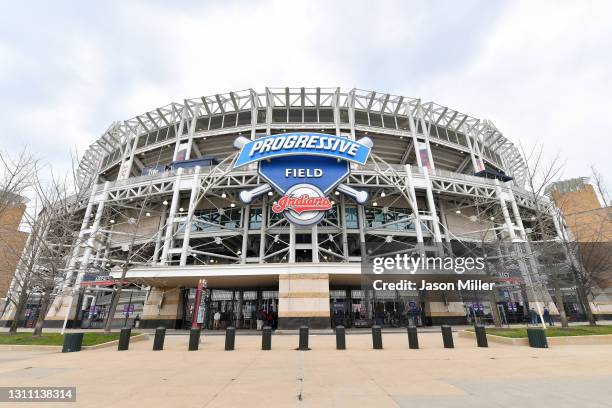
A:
0 0 612 190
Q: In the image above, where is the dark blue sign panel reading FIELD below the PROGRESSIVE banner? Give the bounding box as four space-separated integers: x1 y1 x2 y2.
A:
259 156 349 194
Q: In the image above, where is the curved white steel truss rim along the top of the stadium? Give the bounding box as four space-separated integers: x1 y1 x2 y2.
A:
77 87 526 186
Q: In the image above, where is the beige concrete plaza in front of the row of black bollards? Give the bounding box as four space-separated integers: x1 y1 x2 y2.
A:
0 332 612 408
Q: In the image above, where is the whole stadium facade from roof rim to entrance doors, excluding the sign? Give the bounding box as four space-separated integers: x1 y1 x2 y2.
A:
4 88 580 328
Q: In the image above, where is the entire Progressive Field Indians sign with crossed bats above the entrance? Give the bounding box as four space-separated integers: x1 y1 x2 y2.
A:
234 133 373 225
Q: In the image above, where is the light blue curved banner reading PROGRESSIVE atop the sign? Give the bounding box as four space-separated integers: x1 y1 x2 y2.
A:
234 133 370 167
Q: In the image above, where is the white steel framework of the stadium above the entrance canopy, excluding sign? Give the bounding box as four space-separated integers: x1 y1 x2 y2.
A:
68 88 534 284
